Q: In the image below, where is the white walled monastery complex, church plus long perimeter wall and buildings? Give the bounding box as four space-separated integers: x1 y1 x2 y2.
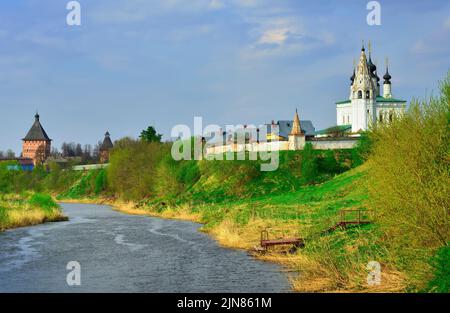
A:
207 46 406 154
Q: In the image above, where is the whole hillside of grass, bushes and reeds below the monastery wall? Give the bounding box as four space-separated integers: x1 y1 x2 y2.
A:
0 73 450 292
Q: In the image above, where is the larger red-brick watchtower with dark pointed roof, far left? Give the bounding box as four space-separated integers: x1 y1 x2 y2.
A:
22 113 52 165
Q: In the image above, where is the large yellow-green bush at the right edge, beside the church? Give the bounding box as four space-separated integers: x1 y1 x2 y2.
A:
368 72 450 288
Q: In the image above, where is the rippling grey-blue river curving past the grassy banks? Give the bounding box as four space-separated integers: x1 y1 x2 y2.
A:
0 204 290 292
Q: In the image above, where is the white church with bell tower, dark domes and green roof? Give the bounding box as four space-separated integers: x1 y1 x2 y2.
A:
336 46 406 133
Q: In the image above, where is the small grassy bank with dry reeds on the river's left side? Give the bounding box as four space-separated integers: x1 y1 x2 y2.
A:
0 193 67 231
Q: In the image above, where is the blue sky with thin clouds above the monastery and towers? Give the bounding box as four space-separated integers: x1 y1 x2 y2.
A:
0 0 450 154
